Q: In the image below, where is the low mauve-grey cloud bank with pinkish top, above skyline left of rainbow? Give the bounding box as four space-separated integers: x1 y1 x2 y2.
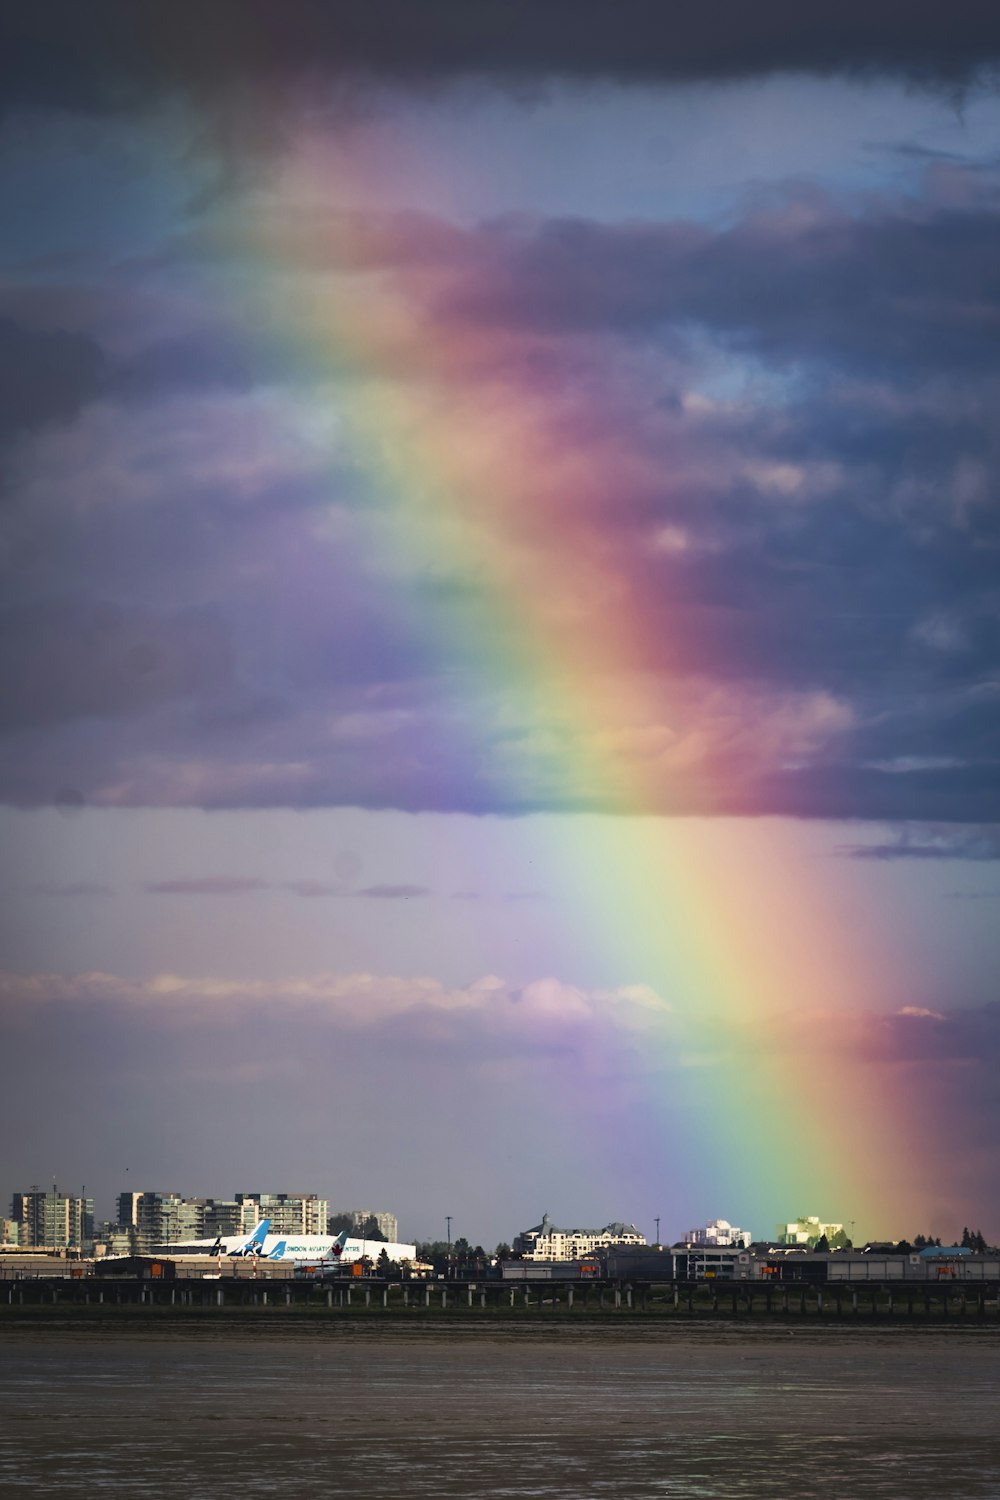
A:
0 974 671 1242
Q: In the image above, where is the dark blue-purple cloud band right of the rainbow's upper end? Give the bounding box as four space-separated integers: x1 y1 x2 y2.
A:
438 191 1000 380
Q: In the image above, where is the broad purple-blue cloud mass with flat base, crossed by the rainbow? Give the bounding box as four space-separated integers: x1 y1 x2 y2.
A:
0 132 1000 822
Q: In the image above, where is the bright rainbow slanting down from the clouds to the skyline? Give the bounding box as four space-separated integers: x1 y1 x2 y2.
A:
206 153 925 1235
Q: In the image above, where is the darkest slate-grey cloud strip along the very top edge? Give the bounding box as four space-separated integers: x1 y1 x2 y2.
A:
3 0 1000 111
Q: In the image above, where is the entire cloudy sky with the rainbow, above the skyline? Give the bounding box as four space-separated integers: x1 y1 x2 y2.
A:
0 0 1000 1244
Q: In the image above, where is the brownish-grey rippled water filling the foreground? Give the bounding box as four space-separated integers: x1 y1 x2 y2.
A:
0 1325 1000 1500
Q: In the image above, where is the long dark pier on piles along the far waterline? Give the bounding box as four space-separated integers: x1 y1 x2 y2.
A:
0 1247 1000 1325
